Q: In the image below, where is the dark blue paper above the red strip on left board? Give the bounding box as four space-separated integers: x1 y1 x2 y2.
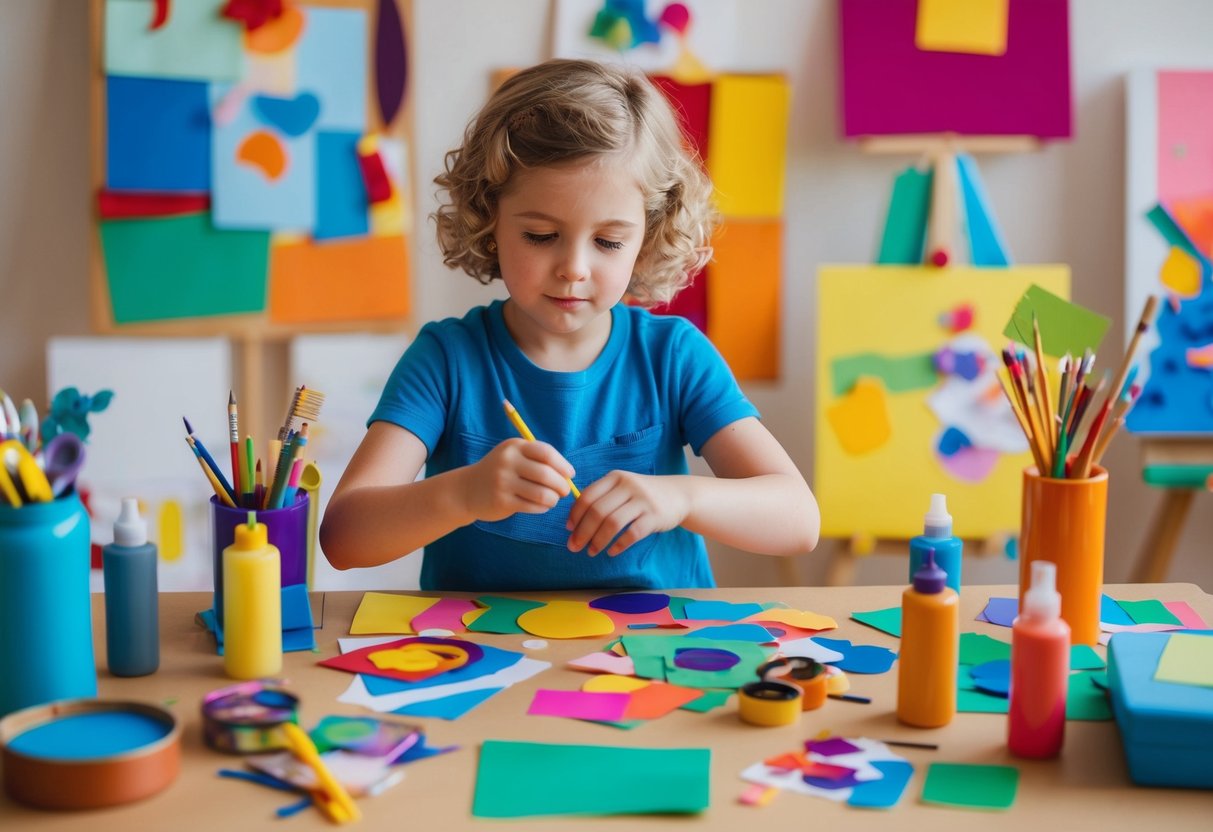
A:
106 76 211 193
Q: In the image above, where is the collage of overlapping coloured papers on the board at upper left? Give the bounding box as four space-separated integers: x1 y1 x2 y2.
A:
98 0 411 334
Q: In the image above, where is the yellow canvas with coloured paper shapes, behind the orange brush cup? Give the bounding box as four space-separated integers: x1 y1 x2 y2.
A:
814 266 1070 538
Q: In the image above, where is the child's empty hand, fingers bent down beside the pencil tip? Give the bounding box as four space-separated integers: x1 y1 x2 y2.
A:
568 471 690 557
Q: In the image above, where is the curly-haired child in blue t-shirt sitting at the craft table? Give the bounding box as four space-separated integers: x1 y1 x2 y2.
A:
320 61 820 591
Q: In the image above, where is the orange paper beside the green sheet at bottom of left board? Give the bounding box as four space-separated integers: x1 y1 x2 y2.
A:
269 235 410 324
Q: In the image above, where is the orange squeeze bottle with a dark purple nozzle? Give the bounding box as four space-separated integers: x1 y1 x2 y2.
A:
898 548 961 728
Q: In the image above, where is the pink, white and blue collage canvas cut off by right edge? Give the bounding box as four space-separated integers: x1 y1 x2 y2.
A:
1124 70 1213 435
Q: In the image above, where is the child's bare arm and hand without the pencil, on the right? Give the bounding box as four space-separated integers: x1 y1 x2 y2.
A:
569 417 821 555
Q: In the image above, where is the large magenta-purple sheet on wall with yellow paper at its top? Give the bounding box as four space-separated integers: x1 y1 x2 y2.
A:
838 0 1072 138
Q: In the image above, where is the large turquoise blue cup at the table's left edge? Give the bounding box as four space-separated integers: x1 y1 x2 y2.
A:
0 491 97 717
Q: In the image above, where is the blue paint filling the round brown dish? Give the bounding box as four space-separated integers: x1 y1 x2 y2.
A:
8 711 172 759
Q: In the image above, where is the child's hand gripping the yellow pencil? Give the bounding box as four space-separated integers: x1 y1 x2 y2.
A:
466 439 574 522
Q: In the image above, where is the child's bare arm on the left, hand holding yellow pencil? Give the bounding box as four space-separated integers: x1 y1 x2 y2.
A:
320 422 574 569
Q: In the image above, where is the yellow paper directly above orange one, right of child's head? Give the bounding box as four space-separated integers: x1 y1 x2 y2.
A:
707 75 791 220
